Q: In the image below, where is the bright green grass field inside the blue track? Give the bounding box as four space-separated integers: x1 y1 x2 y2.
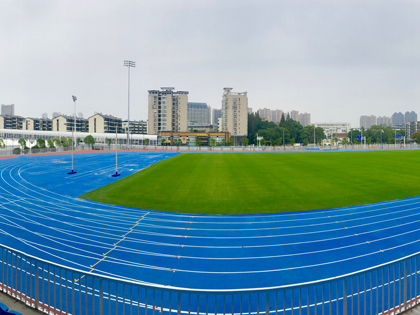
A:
81 151 420 214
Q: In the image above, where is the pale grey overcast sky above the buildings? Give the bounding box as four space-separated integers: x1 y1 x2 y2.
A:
0 0 420 127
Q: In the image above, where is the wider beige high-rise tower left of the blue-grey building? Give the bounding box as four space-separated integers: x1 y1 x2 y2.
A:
147 87 188 135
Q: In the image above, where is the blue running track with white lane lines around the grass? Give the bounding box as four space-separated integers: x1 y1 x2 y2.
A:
0 152 420 314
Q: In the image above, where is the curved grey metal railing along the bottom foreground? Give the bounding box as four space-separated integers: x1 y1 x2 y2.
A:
0 245 420 315
